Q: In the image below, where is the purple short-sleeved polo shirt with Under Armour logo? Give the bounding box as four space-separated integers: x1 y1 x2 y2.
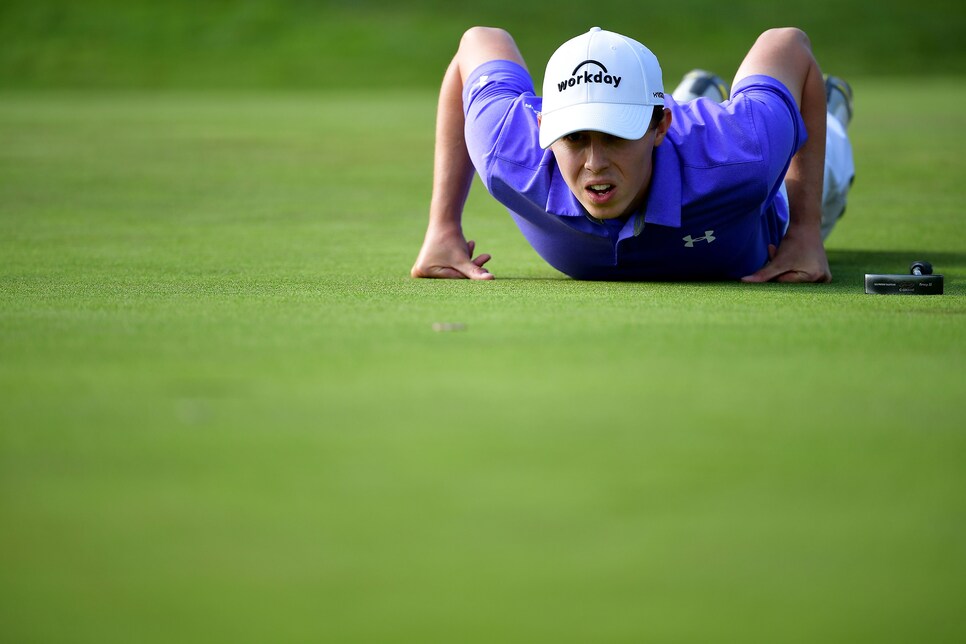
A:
463 60 806 280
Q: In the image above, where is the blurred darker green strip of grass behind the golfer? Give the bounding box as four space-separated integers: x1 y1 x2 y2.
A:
0 0 966 89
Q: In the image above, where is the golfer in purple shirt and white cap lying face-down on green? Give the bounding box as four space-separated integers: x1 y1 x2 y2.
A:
412 27 853 282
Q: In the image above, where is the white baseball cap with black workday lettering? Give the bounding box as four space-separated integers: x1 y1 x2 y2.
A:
540 27 664 149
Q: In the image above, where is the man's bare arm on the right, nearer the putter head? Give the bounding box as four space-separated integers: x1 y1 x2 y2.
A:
735 28 832 282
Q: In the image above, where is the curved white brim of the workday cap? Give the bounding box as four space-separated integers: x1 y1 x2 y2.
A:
540 103 654 150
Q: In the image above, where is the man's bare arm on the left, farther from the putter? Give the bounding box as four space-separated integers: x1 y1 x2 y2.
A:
411 27 525 279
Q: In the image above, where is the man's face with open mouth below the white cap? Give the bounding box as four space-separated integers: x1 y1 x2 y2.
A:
550 113 670 219
